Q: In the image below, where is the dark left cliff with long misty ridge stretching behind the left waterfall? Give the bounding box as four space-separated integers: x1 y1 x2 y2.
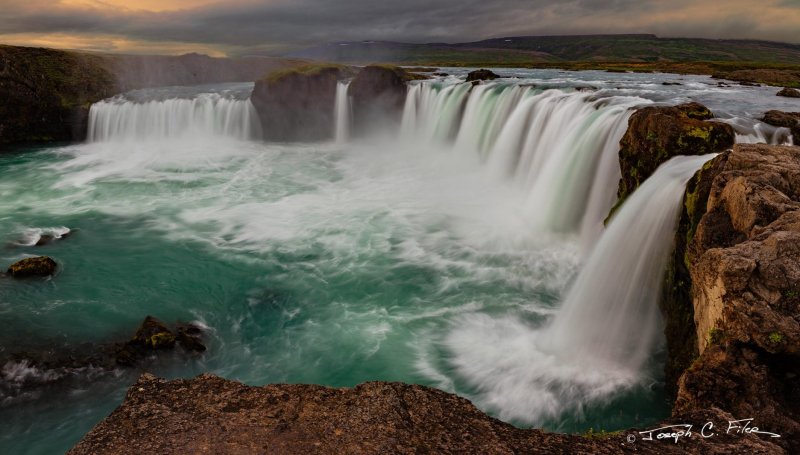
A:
0 45 301 151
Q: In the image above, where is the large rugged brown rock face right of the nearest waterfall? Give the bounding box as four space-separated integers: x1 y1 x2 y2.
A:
675 144 800 452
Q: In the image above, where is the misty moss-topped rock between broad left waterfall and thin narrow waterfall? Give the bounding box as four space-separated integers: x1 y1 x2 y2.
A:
251 64 353 141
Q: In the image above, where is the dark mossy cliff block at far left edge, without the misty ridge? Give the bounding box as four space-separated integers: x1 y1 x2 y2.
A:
0 45 117 150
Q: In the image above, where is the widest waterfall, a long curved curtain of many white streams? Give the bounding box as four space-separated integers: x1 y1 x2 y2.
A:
401 81 650 245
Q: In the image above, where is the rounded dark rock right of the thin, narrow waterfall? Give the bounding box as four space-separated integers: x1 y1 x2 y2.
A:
349 65 418 135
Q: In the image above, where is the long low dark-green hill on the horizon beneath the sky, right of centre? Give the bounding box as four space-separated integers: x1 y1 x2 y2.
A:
288 35 800 66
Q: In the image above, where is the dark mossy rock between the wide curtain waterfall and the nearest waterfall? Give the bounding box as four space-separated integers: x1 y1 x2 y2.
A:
618 103 736 201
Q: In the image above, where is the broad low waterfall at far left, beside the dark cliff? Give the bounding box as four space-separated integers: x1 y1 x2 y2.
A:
88 93 261 142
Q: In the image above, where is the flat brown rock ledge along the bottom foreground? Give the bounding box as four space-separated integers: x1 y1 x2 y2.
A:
68 374 783 455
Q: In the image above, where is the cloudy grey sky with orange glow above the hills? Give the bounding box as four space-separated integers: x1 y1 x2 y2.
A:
0 0 800 55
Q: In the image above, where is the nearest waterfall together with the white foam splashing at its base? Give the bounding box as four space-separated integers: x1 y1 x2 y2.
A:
446 155 711 424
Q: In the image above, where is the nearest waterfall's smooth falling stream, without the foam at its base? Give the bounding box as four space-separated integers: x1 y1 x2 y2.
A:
548 155 713 371
